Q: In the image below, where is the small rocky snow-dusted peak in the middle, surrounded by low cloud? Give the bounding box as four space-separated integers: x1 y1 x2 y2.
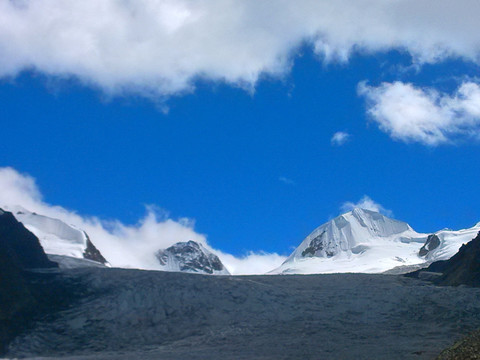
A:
156 240 230 275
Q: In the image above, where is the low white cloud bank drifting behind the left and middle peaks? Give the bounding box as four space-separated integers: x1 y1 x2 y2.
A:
0 167 285 274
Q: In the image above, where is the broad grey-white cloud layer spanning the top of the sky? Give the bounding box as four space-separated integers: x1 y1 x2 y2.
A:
0 0 480 97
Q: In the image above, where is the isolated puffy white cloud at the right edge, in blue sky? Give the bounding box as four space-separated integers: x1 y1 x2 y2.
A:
359 82 480 146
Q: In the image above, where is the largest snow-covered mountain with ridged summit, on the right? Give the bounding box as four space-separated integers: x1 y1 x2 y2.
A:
271 208 480 274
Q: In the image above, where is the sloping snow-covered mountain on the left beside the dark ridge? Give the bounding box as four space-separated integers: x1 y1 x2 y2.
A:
7 207 107 264
